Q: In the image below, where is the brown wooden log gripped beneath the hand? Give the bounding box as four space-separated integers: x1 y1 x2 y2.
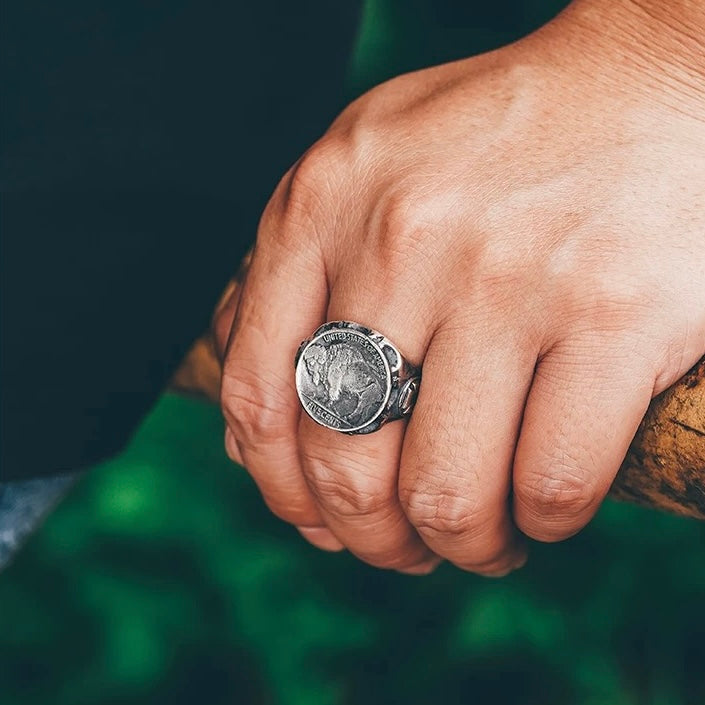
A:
171 260 705 519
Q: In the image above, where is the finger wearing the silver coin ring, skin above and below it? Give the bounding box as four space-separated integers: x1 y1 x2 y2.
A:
299 268 438 573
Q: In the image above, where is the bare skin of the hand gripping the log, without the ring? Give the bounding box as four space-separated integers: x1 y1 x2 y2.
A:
216 0 705 576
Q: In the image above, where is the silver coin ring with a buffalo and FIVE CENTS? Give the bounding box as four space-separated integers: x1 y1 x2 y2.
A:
294 321 421 434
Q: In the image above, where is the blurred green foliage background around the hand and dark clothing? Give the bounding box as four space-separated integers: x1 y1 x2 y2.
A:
0 0 705 705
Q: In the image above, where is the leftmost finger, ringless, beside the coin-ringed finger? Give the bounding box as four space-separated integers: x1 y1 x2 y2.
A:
221 170 330 528
